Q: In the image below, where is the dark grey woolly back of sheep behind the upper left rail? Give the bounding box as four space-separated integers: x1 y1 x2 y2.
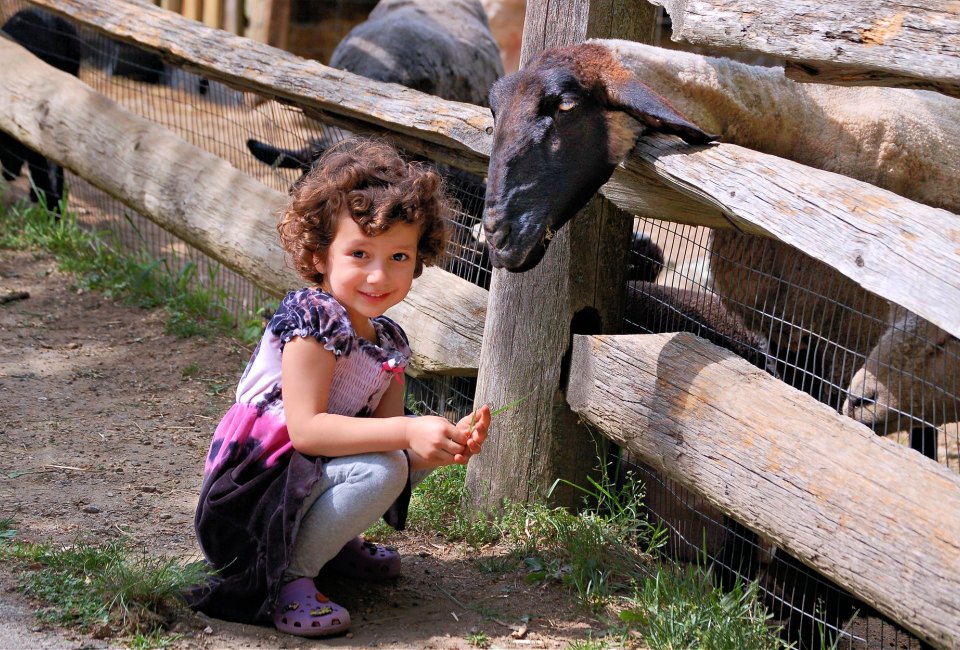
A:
330 0 503 106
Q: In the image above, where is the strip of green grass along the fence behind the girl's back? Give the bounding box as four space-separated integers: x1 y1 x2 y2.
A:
0 195 262 342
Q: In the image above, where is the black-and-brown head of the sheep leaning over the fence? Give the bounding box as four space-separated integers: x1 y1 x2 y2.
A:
483 43 717 272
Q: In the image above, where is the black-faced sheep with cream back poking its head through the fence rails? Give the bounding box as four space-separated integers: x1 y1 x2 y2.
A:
484 40 960 448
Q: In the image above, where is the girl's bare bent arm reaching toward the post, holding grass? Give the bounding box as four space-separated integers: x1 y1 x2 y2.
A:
281 337 465 466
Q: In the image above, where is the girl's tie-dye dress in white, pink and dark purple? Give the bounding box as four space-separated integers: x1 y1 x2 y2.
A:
189 289 410 623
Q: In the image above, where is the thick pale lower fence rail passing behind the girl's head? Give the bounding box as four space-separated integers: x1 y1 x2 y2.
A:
0 39 487 374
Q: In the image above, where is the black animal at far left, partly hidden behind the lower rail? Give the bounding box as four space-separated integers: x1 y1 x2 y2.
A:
0 9 80 213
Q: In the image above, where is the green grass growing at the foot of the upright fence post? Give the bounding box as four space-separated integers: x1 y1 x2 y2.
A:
394 450 788 650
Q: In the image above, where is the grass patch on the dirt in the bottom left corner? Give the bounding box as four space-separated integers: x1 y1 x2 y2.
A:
0 522 209 636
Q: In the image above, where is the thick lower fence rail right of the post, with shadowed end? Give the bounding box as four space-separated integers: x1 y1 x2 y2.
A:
567 333 960 648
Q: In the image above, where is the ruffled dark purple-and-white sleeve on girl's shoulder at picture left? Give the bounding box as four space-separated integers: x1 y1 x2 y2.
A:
267 289 354 357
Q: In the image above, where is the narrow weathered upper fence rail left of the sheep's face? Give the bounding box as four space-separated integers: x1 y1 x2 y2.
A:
25 0 493 174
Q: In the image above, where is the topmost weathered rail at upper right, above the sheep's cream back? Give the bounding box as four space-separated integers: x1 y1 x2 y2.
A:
651 0 960 97
